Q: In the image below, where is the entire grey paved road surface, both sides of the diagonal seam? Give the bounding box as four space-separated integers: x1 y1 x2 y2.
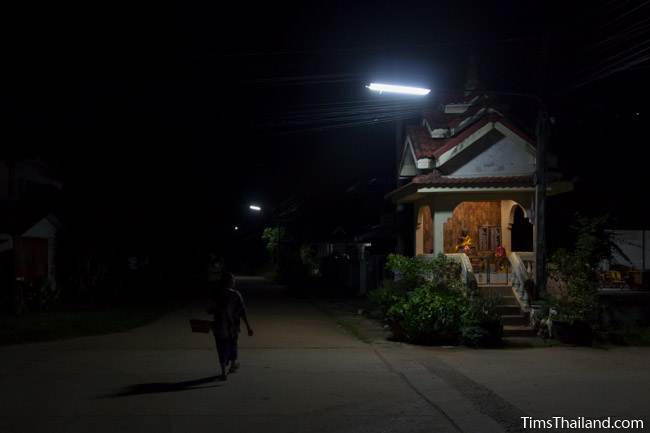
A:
0 278 650 433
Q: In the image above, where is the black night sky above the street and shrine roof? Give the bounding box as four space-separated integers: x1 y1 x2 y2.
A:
5 1 650 256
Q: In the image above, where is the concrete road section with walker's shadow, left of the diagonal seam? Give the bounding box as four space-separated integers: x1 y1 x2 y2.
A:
0 278 458 433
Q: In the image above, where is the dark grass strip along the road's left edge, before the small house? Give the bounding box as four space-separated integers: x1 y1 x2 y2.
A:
0 303 179 345
